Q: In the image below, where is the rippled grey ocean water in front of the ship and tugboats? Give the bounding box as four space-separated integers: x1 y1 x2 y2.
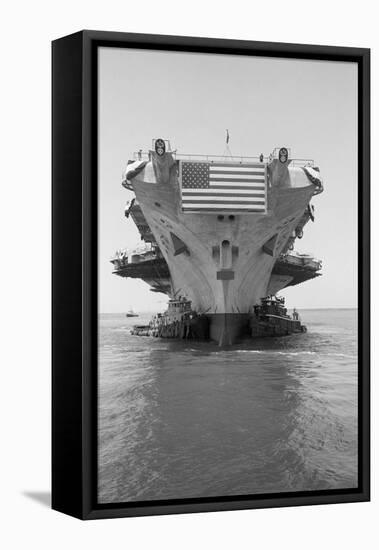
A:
98 309 357 503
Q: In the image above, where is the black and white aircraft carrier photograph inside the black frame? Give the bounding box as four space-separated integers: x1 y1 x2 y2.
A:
97 47 359 504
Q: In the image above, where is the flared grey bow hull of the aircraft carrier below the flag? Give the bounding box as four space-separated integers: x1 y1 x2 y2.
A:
131 153 320 345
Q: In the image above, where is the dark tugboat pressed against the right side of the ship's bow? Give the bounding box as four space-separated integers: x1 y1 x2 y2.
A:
250 296 307 338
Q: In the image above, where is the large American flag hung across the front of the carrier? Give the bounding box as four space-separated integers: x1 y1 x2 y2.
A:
180 161 266 213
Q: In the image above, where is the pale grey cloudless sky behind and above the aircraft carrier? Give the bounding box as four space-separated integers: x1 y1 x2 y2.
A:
98 47 358 313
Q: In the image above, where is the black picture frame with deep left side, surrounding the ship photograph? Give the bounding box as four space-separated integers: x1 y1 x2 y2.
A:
52 31 370 519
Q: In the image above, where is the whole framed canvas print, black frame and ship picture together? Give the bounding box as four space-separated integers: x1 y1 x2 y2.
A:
52 31 370 519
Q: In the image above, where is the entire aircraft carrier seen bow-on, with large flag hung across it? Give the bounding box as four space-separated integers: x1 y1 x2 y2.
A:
112 139 322 344
